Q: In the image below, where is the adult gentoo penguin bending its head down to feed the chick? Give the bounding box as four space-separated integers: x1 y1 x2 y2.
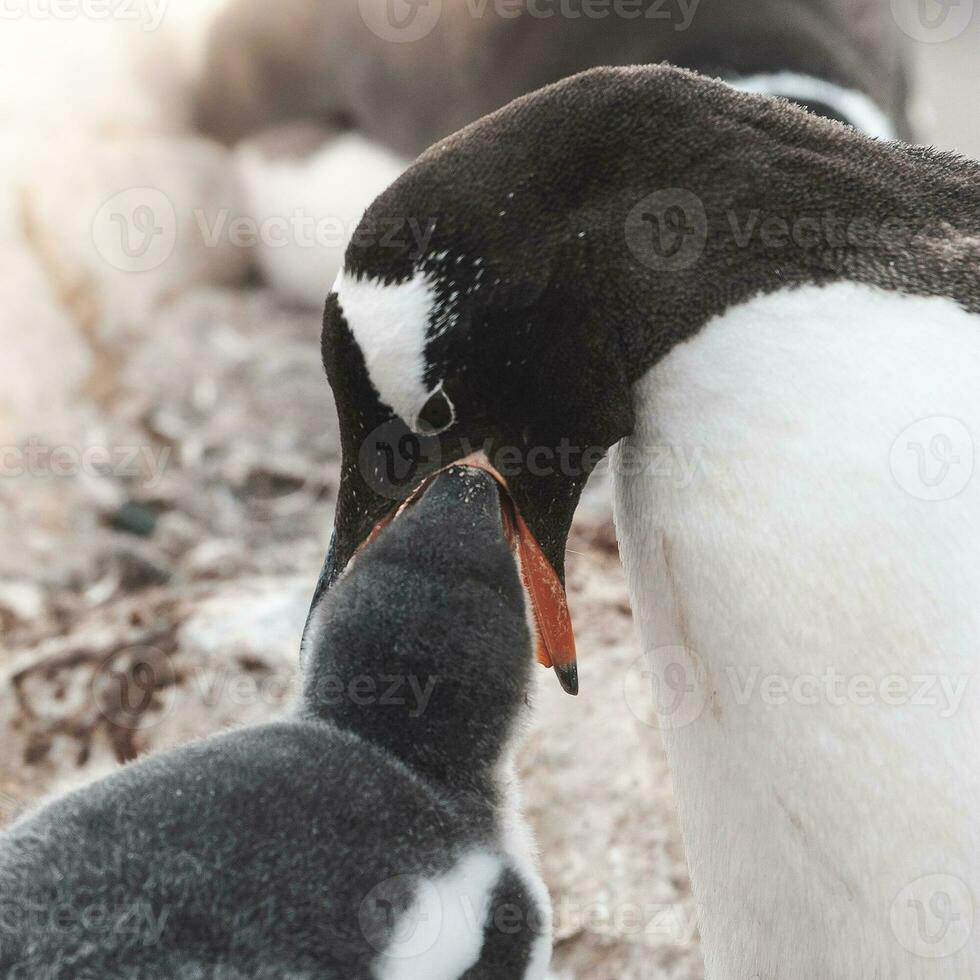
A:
322 67 980 980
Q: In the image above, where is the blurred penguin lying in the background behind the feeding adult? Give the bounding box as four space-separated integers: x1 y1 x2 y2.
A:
196 0 909 309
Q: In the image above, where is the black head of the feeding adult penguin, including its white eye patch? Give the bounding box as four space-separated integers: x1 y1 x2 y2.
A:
323 70 694 687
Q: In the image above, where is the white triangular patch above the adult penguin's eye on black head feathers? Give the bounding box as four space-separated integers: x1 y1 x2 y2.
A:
333 271 438 431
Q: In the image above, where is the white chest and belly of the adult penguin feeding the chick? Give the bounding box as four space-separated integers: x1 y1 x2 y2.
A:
613 284 980 980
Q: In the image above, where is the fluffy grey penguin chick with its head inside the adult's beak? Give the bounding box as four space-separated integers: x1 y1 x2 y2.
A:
0 467 551 980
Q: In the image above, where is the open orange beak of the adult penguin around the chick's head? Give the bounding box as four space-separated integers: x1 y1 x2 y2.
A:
358 452 578 695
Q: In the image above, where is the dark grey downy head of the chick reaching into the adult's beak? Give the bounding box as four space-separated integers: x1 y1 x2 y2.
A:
303 466 532 786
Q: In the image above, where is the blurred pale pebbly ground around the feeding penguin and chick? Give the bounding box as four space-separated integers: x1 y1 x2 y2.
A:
0 4 976 980
